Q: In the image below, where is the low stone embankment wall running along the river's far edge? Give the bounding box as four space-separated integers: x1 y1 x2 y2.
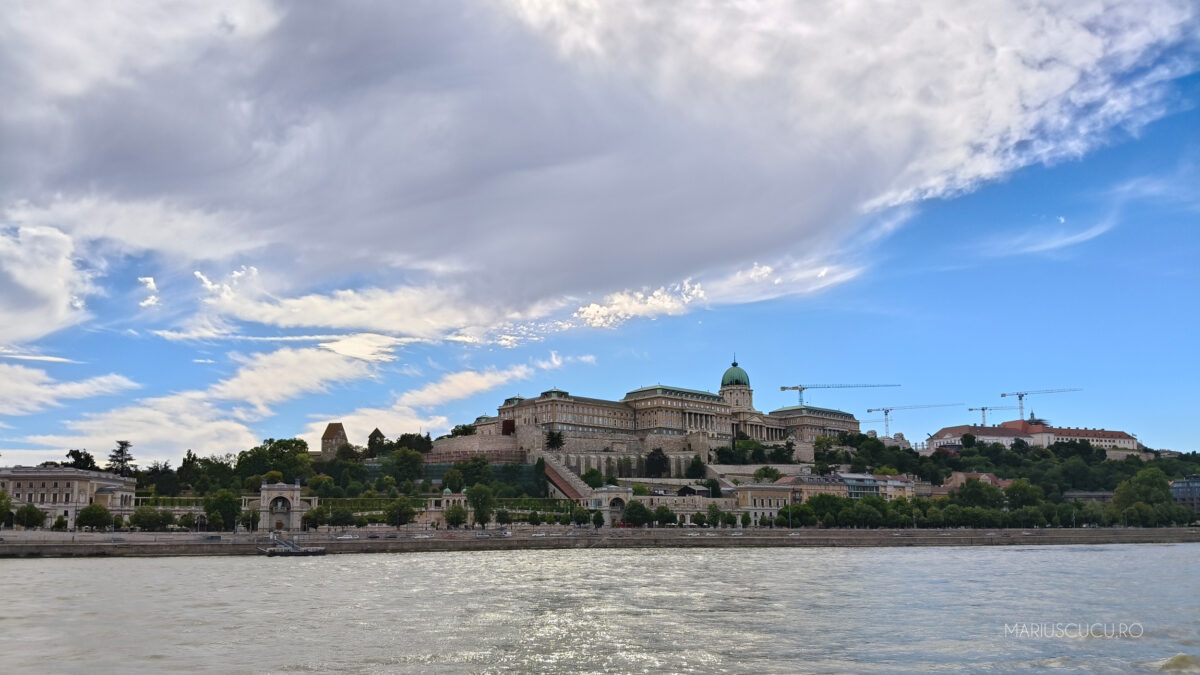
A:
0 527 1200 557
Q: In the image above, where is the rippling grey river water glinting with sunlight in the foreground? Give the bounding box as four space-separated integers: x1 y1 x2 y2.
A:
0 544 1200 673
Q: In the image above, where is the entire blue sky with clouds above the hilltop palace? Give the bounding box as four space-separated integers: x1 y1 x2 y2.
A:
0 0 1200 466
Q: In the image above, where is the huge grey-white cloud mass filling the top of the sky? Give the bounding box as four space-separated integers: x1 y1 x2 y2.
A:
0 0 1198 345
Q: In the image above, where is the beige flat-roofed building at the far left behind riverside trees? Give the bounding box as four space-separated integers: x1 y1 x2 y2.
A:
0 466 137 528
